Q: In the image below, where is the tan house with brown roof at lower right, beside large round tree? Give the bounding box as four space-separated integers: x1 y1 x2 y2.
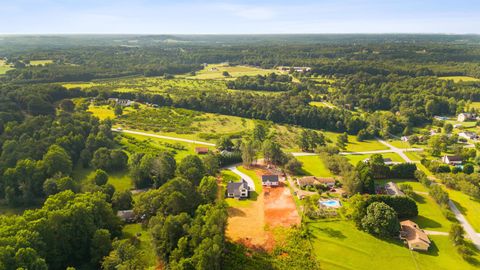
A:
400 220 431 251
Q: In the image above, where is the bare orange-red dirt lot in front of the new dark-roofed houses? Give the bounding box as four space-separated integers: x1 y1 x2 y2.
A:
227 167 300 250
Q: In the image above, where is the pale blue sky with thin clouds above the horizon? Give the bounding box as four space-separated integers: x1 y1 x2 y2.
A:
0 0 480 34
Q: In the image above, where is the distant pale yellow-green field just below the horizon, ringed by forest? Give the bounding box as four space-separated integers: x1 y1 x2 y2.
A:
181 64 281 80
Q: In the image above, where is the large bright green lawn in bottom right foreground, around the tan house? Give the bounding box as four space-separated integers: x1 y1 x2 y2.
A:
309 221 478 270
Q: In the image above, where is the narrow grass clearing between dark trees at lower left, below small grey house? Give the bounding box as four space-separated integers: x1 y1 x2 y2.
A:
122 224 157 269
